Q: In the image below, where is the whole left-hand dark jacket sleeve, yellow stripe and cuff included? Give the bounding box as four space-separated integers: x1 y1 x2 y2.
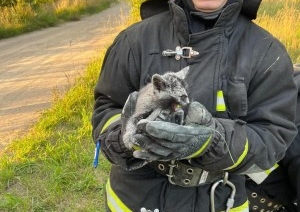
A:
92 32 144 169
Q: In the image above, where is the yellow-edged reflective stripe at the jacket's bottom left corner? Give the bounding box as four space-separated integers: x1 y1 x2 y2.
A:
106 180 132 212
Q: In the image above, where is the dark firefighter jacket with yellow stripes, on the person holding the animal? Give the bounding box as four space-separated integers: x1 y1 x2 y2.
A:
92 0 297 212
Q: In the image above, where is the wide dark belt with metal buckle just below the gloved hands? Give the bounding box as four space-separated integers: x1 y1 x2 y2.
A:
148 160 223 187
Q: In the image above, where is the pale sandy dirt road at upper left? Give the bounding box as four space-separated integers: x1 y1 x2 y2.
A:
0 3 129 150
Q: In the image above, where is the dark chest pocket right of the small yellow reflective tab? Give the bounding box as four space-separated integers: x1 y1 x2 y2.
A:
222 77 248 118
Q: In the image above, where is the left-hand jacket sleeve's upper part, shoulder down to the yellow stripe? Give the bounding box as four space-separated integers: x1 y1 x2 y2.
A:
92 29 137 141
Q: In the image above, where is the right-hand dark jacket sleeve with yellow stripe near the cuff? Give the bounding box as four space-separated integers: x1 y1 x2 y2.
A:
193 40 297 174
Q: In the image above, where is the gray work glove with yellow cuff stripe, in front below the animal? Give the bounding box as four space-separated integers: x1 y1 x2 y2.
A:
133 102 224 161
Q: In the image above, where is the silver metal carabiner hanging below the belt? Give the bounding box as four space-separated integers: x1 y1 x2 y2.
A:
210 172 236 212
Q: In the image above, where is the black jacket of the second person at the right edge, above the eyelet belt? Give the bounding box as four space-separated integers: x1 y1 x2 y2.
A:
246 65 300 212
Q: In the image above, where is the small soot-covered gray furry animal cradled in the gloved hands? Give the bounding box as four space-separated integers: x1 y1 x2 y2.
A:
123 66 189 149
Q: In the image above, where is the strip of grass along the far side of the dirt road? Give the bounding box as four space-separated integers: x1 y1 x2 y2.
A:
0 0 117 39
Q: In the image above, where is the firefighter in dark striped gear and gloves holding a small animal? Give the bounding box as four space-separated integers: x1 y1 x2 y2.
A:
92 0 297 212
